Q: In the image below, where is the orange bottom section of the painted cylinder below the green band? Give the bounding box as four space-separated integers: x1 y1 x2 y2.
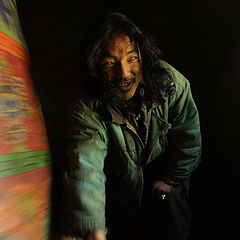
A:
0 167 51 240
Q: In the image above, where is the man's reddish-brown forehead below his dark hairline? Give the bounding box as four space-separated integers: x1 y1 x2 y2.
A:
103 30 137 54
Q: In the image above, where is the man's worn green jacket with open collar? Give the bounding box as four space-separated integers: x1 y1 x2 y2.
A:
64 61 201 236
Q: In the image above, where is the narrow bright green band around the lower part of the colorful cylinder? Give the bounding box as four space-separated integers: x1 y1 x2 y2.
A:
0 149 51 178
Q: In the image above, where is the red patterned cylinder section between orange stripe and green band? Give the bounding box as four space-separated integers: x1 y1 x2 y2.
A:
0 47 48 155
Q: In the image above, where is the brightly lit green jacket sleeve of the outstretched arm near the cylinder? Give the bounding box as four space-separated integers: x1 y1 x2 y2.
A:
63 102 107 236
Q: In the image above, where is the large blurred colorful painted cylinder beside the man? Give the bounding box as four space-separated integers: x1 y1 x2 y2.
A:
0 0 51 240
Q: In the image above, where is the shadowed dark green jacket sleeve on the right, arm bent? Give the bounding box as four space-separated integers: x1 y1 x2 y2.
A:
161 63 201 182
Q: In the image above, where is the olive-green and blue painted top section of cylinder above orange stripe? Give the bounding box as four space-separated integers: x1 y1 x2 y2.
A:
0 0 28 51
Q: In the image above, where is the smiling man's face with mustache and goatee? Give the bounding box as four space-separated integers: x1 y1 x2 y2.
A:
98 30 142 100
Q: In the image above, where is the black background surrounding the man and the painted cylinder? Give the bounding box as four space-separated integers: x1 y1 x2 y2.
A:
17 0 240 240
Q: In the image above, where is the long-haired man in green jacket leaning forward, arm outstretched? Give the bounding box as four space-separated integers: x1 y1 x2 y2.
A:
63 13 201 240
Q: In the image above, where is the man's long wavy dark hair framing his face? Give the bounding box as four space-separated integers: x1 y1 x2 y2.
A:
80 12 175 106
